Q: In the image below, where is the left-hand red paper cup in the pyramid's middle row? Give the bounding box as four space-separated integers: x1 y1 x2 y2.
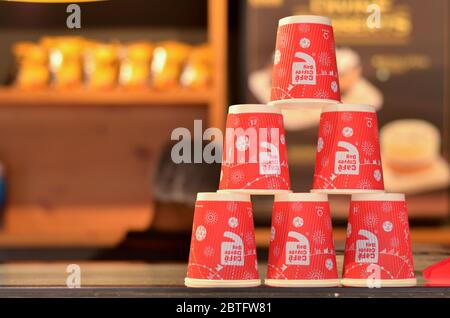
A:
219 105 290 194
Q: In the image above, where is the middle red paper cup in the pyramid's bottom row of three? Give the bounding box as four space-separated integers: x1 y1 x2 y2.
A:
265 193 339 287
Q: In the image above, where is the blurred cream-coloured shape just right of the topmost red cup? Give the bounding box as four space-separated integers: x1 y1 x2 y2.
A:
336 47 383 110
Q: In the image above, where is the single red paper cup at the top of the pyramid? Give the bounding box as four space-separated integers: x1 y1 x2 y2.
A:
269 15 341 108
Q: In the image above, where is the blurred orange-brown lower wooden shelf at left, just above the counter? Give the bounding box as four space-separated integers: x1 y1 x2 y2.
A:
0 205 153 248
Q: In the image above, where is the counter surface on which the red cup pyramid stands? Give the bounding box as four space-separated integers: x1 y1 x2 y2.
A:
0 246 450 298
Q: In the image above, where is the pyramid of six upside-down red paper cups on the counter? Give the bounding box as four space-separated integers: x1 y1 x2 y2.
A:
185 16 416 287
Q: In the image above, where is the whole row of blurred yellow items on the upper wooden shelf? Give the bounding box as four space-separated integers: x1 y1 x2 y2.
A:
13 36 213 91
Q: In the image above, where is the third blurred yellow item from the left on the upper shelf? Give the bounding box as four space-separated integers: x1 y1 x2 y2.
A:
83 42 119 89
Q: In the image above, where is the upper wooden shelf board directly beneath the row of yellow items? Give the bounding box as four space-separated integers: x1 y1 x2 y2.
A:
0 88 212 107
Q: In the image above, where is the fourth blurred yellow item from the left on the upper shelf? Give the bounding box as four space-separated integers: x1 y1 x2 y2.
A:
119 42 153 88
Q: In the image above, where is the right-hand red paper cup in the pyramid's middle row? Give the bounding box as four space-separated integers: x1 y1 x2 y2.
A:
312 104 384 194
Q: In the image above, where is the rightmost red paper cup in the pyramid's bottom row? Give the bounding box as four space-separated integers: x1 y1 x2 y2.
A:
341 193 416 287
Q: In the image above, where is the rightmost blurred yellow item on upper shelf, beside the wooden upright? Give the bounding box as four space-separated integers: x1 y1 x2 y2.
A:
180 45 213 89
